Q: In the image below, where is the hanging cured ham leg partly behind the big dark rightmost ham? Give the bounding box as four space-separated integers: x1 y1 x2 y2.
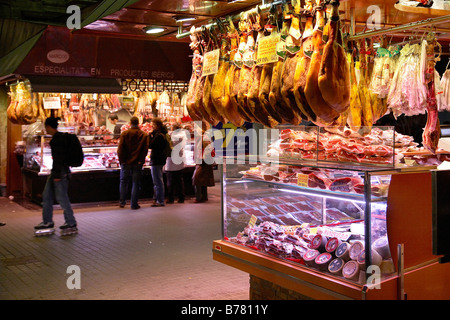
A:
305 0 339 126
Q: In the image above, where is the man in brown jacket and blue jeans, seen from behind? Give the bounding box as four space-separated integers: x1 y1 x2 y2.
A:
117 117 148 210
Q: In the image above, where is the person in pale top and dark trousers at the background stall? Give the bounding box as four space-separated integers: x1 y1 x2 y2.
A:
164 122 188 203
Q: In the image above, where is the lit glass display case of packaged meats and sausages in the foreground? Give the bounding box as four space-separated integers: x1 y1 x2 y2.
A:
223 158 394 283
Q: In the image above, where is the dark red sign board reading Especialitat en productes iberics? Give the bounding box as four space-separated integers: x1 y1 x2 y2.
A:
15 27 192 81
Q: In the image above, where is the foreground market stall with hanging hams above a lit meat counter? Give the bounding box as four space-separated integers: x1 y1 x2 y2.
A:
180 1 450 299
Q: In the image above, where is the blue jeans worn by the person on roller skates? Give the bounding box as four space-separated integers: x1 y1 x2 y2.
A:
42 169 77 226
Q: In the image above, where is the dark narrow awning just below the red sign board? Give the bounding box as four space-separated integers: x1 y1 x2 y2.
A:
24 76 122 94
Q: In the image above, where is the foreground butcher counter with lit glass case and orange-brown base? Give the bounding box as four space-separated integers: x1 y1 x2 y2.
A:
212 158 450 300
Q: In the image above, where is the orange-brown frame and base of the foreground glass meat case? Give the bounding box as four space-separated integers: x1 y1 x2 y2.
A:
212 125 450 300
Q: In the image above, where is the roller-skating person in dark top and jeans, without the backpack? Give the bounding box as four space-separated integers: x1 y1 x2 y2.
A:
34 117 77 230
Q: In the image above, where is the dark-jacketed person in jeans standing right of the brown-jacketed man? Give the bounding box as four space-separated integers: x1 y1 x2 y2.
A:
149 118 168 207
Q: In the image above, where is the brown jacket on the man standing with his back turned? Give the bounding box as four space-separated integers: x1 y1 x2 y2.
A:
117 127 148 165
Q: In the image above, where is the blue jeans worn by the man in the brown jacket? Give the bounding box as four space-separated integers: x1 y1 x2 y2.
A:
119 164 142 208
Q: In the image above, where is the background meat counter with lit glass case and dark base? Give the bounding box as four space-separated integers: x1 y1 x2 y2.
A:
22 122 195 204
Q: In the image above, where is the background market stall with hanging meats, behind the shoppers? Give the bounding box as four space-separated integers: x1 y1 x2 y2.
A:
8 81 194 204
